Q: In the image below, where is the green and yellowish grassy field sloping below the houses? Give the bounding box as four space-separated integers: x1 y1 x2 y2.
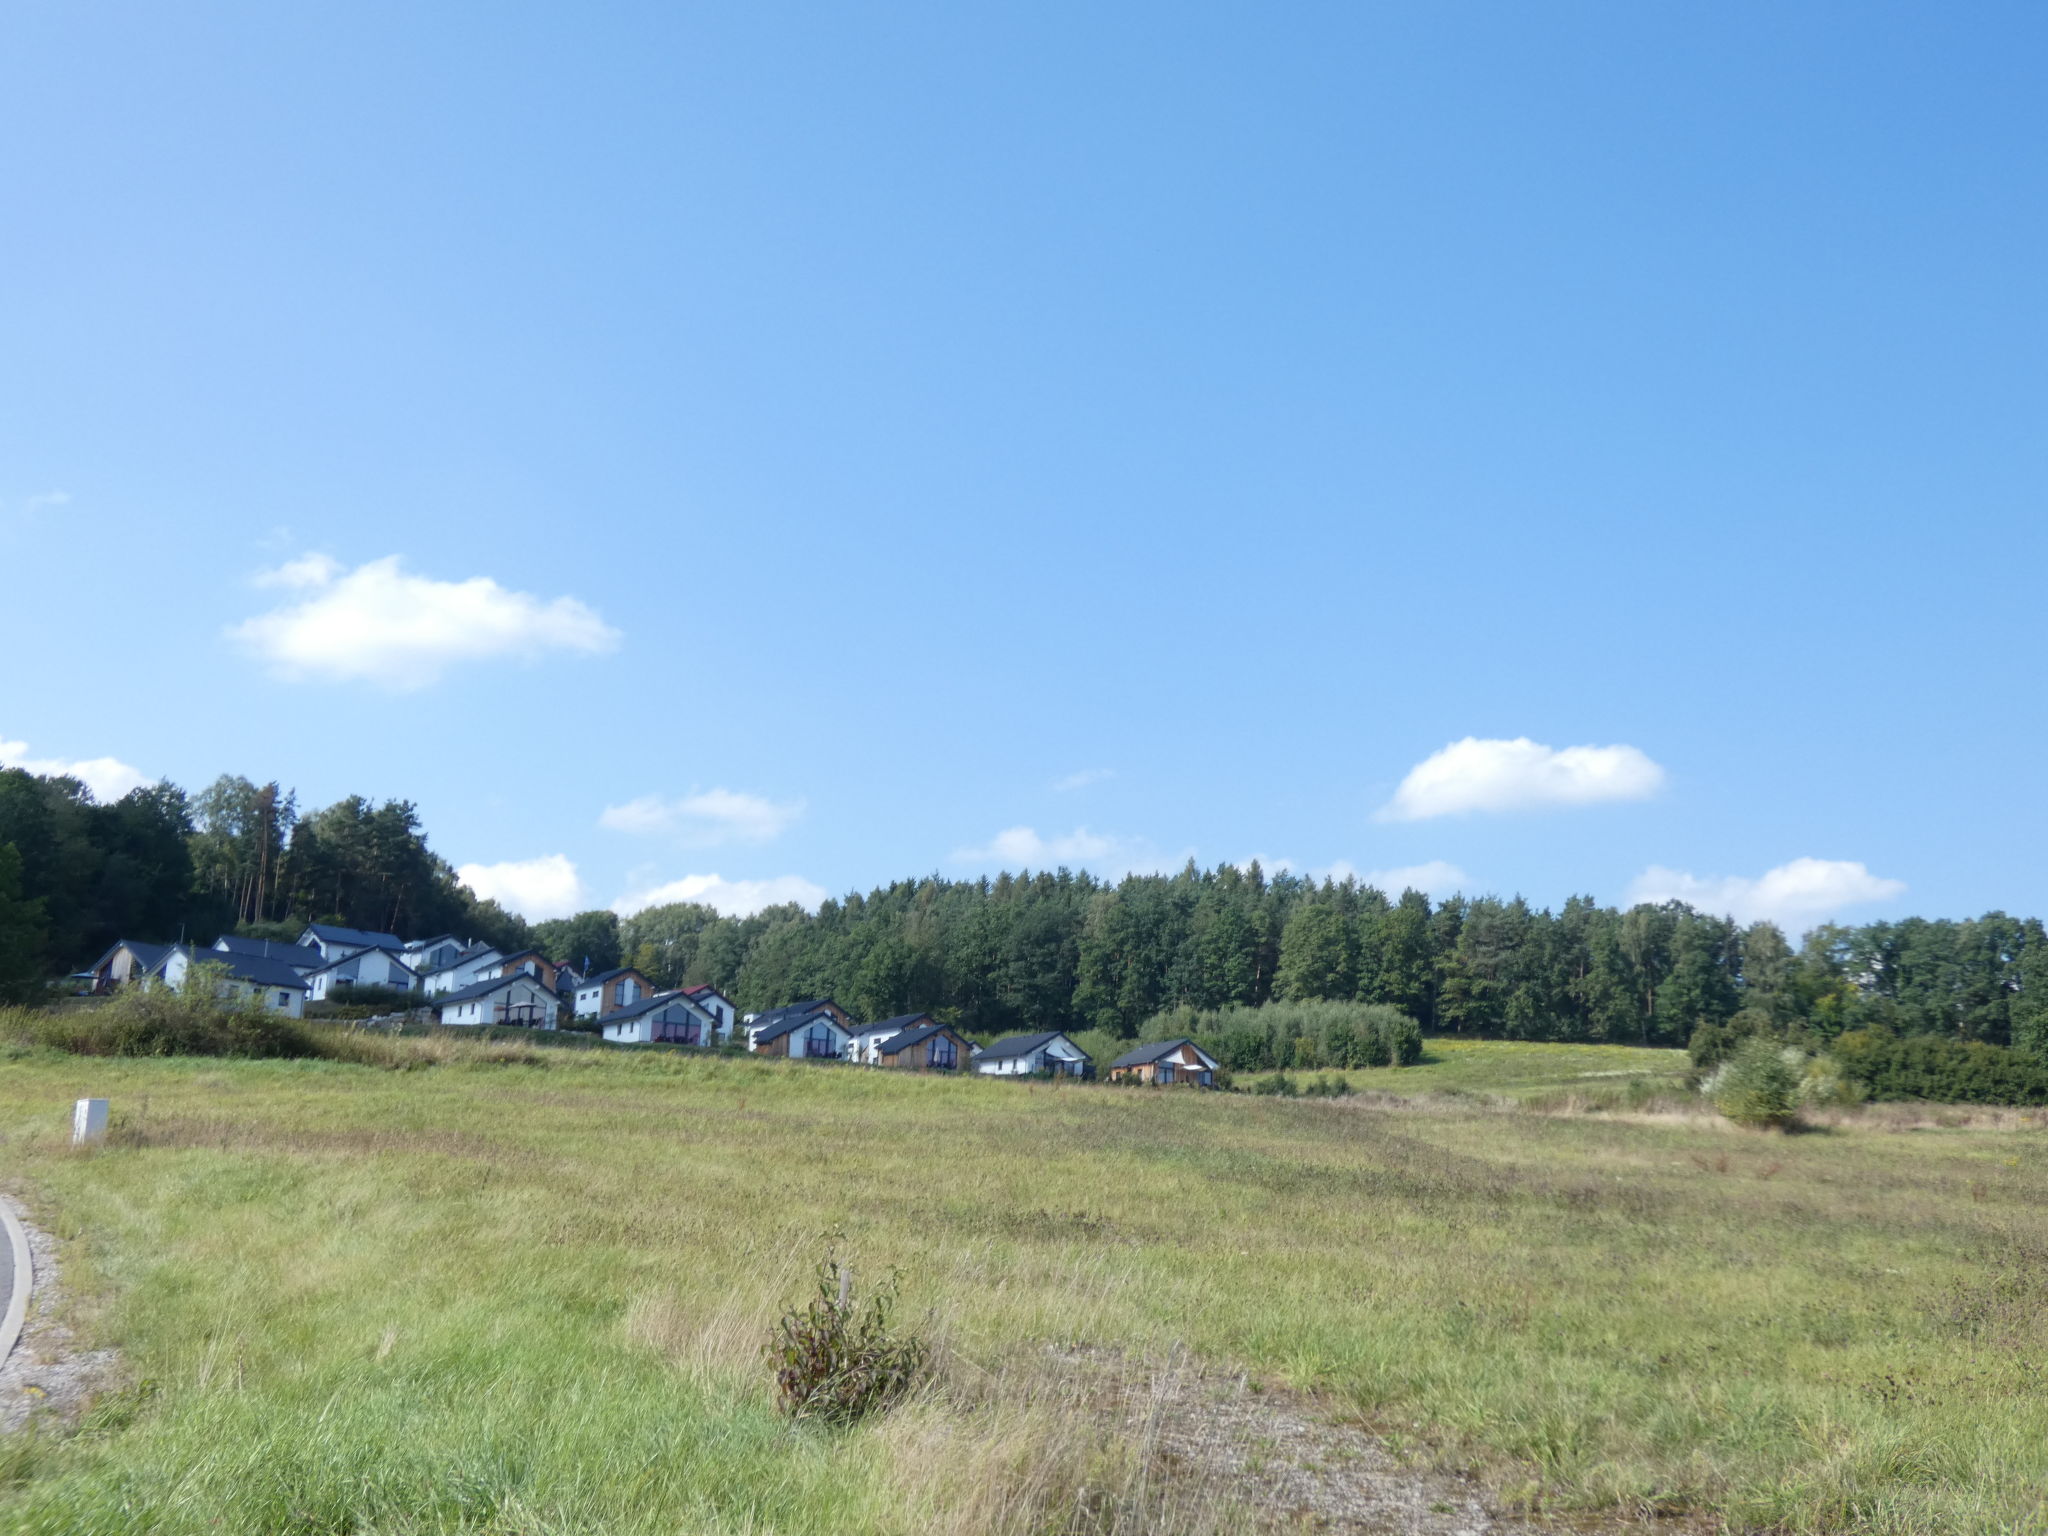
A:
0 1040 2048 1536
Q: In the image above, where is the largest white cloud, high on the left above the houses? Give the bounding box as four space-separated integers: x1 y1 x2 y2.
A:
227 555 618 690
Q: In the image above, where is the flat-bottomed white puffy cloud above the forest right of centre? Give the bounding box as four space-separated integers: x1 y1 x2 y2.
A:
1376 735 1665 821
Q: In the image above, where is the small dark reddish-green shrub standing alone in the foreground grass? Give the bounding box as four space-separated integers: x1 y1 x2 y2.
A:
768 1253 932 1423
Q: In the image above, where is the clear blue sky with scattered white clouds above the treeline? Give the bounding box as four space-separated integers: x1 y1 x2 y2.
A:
0 0 2048 926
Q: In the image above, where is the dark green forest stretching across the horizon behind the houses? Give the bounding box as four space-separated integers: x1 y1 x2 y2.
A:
0 770 2048 1059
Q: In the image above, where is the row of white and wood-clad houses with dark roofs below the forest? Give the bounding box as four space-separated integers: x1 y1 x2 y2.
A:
78 924 1219 1087
